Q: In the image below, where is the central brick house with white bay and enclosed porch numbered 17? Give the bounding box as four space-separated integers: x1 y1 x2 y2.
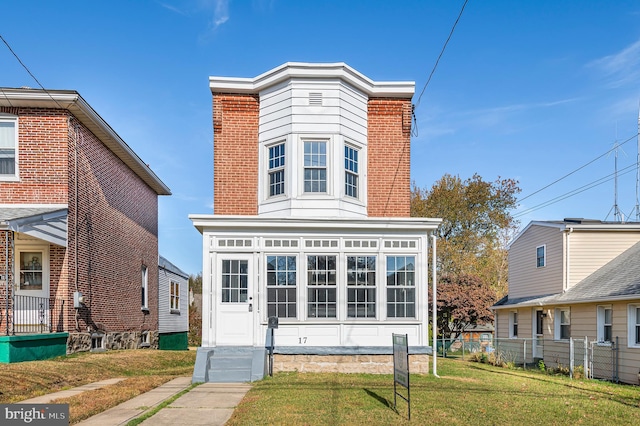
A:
190 63 440 381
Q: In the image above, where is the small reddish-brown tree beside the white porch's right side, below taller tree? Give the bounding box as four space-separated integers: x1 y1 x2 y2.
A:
429 274 496 339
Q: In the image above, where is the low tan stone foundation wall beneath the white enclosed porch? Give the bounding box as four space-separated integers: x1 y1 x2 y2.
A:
273 354 429 374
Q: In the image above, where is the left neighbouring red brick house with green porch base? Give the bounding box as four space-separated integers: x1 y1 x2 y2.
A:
0 88 170 361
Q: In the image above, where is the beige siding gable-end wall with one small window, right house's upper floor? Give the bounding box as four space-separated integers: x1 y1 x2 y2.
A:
509 225 564 299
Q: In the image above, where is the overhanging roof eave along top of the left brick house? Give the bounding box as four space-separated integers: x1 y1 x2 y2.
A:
0 87 171 195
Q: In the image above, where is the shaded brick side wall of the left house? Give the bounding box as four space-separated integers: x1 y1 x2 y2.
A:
67 120 158 332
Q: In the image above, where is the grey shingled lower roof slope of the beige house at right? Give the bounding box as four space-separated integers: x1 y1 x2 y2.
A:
493 242 640 307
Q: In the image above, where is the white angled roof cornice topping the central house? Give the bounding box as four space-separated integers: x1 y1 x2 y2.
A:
209 62 415 99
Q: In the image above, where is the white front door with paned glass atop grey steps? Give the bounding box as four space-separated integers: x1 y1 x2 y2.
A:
216 254 255 346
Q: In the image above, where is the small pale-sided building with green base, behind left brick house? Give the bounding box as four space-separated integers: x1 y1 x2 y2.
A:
158 256 189 350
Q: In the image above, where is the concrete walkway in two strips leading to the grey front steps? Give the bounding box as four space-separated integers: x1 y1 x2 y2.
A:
78 377 251 426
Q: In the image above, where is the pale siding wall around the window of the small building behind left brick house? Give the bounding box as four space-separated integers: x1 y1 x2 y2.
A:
158 267 189 333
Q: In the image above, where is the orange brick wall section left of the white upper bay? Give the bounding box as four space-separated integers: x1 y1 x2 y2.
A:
213 93 260 215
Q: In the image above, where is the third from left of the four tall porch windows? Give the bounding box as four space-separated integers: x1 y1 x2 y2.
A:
347 256 376 318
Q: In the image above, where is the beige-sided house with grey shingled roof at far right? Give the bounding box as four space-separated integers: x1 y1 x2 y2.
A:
493 219 640 384
